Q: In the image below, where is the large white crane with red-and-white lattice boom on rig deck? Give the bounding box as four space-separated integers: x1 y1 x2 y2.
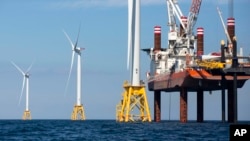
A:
166 0 202 50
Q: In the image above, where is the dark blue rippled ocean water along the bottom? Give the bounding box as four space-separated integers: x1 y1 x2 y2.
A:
0 120 244 141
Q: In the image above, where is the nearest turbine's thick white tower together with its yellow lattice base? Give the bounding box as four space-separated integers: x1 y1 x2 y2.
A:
116 0 151 122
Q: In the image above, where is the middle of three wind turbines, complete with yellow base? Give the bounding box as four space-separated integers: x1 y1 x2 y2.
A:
63 27 85 120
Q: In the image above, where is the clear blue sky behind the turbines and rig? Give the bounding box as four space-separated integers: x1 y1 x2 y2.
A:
0 0 250 120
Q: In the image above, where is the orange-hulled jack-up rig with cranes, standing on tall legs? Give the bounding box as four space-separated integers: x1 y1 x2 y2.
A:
143 0 250 122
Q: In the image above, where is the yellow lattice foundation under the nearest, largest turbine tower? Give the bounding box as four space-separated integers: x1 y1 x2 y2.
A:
116 81 151 122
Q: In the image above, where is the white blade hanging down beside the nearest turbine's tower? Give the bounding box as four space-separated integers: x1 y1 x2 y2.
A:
127 0 133 69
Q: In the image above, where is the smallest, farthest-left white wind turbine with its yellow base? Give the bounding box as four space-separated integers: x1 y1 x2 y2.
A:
11 62 33 120
